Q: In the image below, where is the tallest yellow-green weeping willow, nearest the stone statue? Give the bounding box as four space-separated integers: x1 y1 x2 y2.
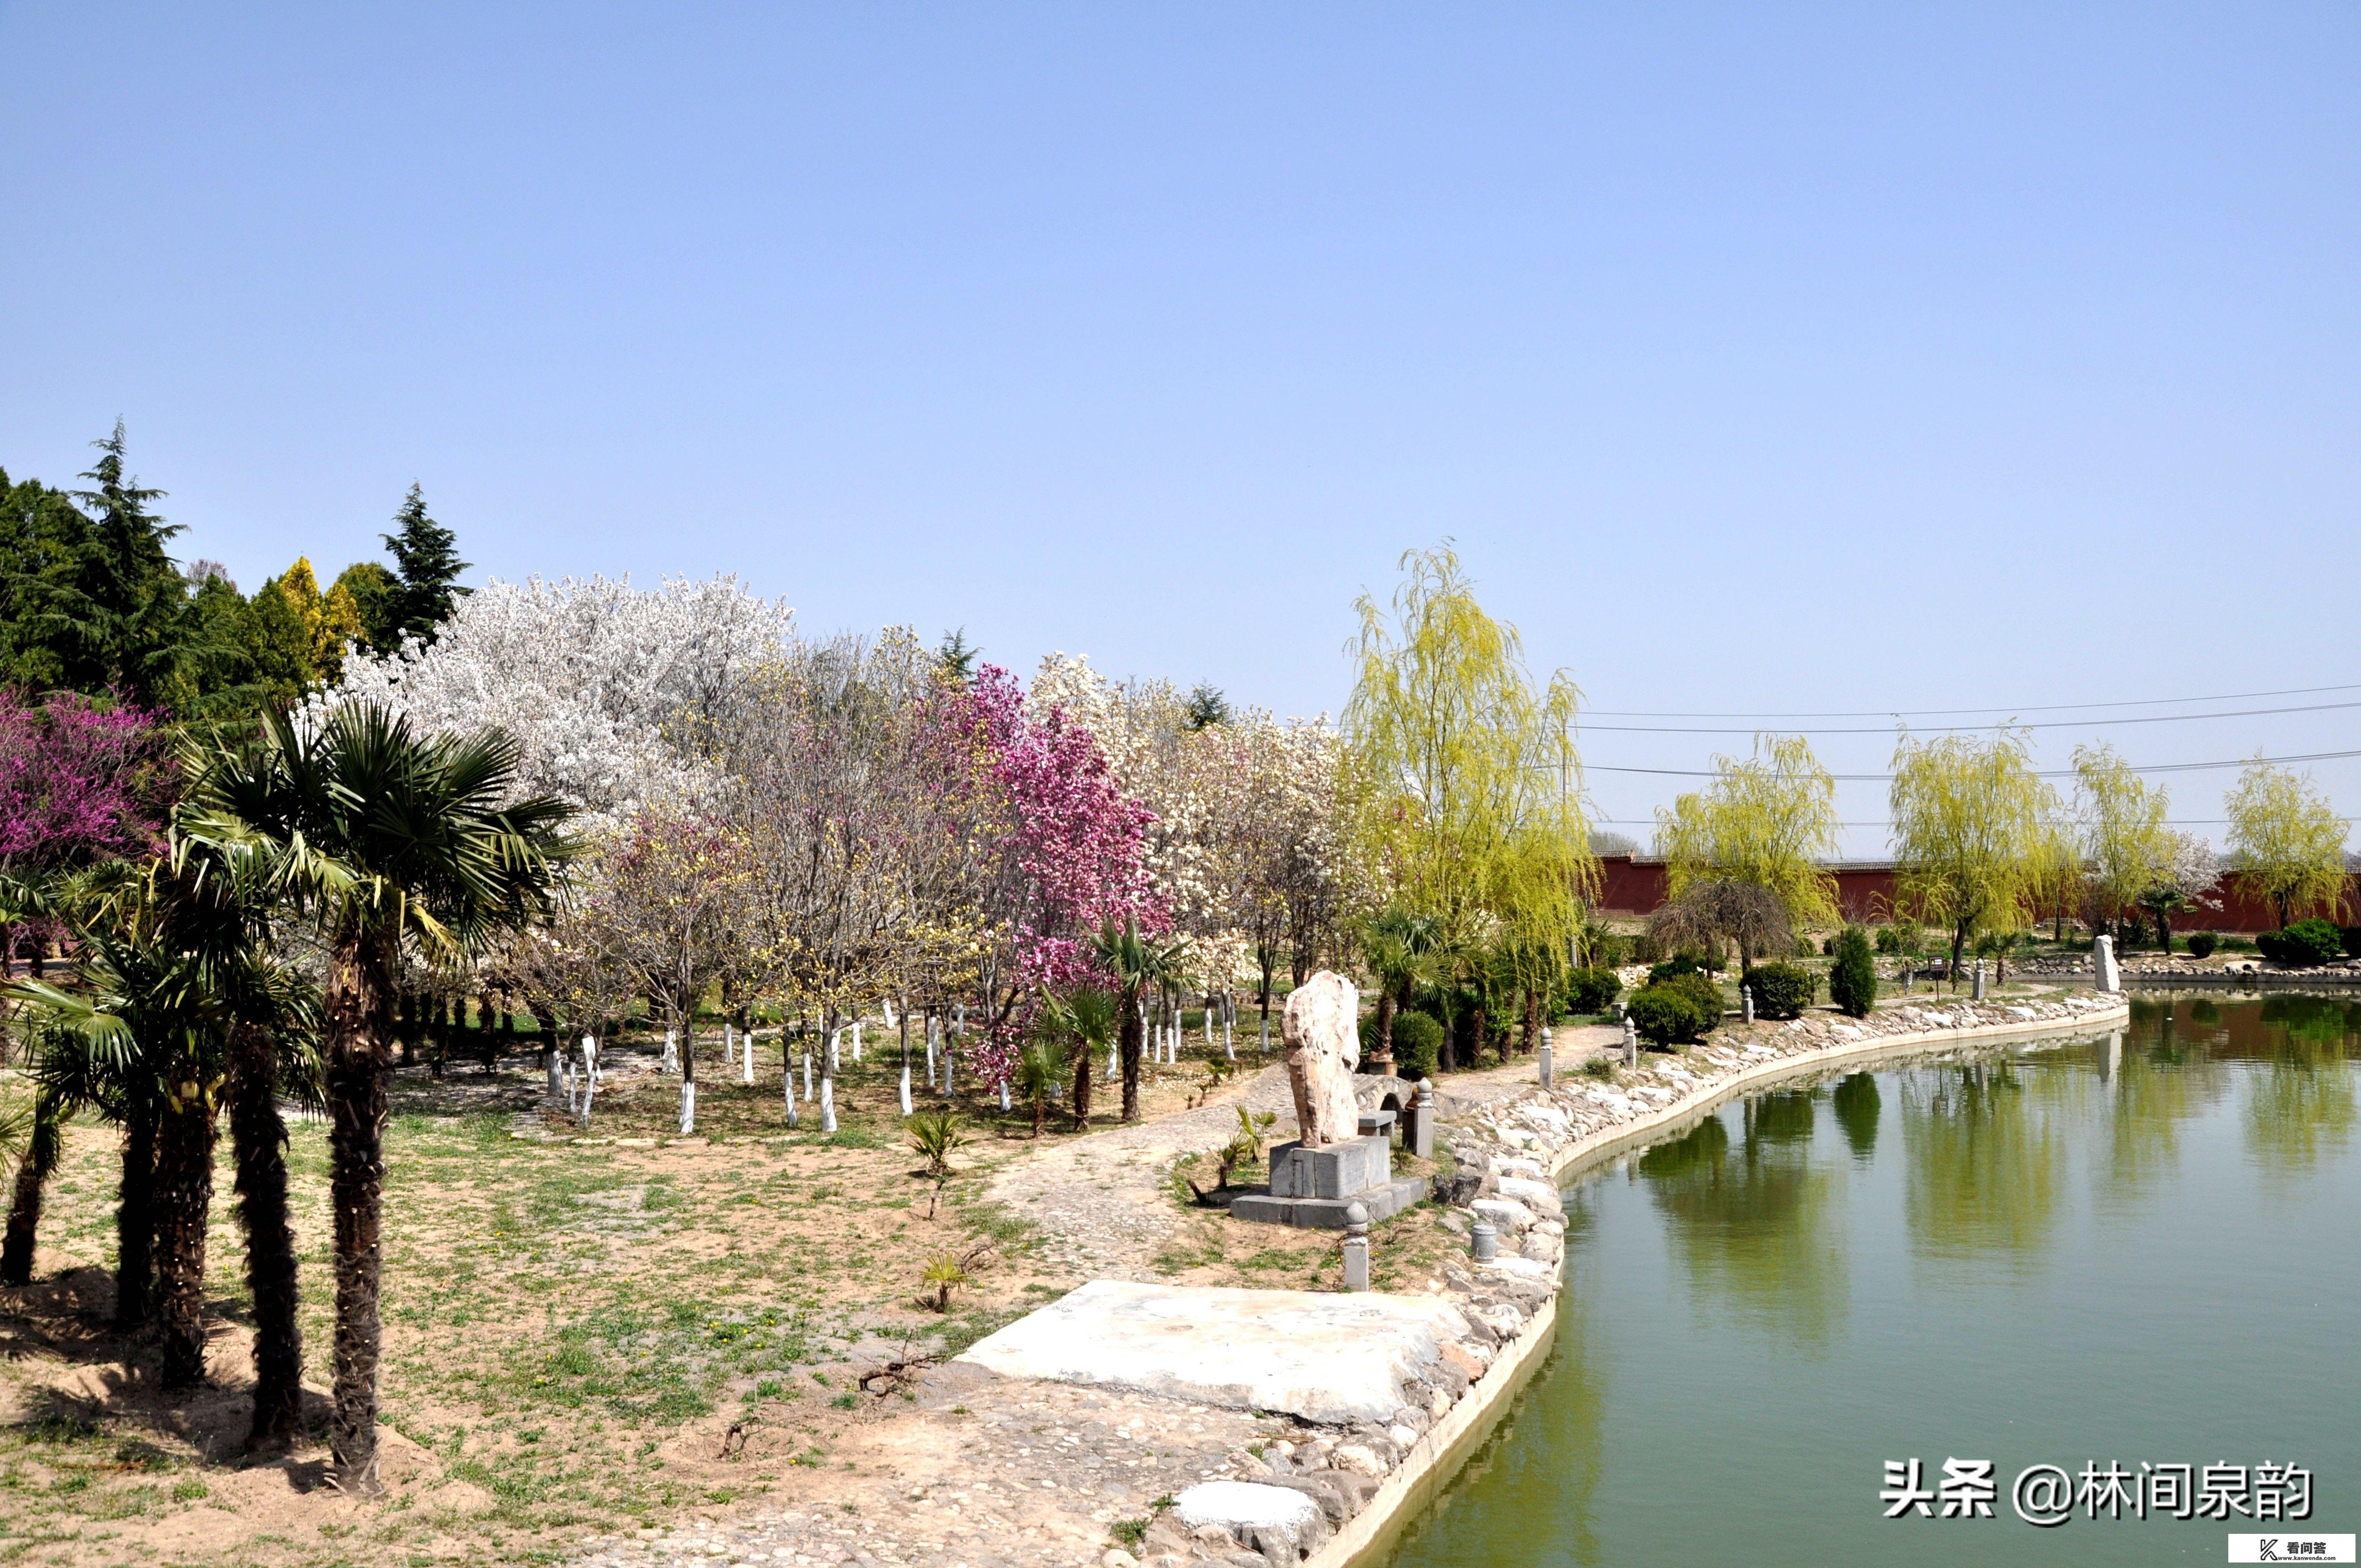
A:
1343 541 1598 1067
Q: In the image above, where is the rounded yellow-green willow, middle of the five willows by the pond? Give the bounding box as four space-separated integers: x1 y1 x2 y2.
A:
1889 727 2057 980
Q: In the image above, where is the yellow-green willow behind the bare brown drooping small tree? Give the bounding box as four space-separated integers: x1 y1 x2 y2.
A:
1655 734 1839 959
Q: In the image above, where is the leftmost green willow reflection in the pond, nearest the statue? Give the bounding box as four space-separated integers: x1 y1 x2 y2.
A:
1636 1091 1849 1346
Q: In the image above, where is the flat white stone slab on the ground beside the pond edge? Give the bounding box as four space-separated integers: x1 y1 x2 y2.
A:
959 1280 1471 1424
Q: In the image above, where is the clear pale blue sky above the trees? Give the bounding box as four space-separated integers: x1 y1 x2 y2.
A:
0 2 2361 852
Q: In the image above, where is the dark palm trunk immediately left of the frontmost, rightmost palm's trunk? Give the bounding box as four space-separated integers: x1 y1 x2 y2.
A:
229 1022 302 1450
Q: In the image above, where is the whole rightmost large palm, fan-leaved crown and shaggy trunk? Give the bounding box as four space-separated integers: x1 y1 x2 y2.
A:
191 704 576 1497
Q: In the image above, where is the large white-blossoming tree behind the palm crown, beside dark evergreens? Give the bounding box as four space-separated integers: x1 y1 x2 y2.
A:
312 576 793 831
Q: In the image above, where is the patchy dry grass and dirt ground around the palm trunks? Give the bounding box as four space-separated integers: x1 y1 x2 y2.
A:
0 1035 1334 1568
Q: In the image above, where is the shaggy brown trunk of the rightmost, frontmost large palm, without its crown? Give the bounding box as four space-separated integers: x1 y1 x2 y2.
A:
321 933 394 1497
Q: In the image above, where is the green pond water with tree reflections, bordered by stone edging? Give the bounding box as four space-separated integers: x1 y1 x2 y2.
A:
1393 997 2361 1568
